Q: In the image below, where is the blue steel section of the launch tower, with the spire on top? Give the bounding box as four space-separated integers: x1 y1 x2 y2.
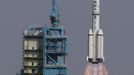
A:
43 0 67 75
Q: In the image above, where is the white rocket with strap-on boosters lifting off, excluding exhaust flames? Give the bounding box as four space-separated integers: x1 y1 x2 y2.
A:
87 0 104 64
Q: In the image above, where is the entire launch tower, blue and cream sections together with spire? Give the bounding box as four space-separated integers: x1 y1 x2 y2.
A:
17 0 67 75
